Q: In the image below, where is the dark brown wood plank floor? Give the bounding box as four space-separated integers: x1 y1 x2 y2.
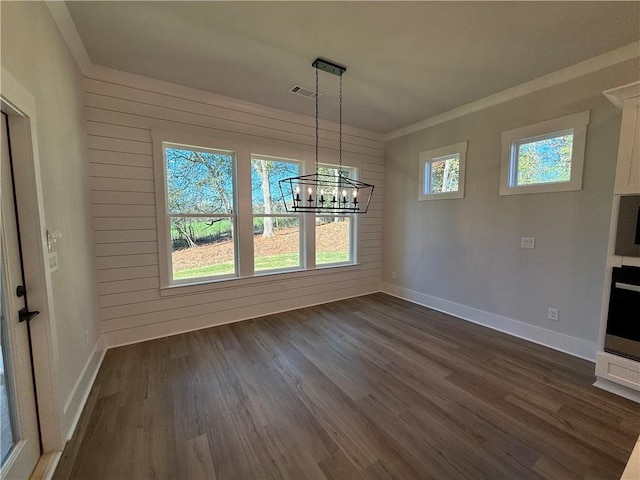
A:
54 294 640 480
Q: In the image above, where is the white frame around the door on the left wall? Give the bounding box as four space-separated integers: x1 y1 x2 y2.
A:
0 67 65 457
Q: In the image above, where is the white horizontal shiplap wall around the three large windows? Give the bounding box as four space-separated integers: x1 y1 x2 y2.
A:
85 72 384 346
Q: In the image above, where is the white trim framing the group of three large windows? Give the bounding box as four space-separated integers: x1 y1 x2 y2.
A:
151 128 361 290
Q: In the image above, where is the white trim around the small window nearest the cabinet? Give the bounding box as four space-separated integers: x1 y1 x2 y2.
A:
500 110 589 195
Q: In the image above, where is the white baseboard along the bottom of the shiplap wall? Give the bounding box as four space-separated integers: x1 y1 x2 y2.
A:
102 284 380 349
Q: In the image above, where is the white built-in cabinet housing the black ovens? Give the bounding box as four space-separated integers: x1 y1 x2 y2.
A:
595 81 640 402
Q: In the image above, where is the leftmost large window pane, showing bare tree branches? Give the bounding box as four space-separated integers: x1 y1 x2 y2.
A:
163 143 237 283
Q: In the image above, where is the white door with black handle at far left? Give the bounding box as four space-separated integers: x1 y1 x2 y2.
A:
0 112 40 480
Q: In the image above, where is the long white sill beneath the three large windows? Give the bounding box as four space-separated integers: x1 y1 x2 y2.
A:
160 263 360 297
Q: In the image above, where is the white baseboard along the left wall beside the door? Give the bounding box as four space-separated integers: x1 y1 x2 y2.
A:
62 337 106 441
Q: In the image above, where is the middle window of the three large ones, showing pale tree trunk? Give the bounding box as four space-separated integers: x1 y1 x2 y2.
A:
251 155 302 272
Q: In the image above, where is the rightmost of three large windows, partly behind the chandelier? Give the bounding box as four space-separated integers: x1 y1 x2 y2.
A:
315 165 356 265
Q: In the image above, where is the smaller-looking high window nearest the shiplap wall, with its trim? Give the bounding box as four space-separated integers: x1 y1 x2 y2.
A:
418 142 467 200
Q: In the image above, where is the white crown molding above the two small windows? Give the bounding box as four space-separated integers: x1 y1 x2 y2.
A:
382 42 640 142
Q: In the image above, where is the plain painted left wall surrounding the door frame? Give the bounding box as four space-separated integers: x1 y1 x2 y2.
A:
1 2 100 442
